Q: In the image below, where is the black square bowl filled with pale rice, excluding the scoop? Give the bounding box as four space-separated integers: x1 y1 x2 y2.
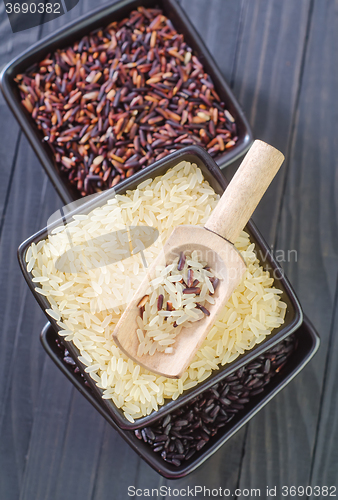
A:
18 146 303 429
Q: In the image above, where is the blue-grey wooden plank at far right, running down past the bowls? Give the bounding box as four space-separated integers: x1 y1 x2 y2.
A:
240 0 338 488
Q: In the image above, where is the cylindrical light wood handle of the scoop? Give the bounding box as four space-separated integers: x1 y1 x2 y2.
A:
205 141 284 243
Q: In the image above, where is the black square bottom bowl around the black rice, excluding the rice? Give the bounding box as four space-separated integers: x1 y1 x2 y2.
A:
40 318 320 479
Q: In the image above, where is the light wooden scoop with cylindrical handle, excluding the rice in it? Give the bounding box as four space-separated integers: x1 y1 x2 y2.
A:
113 141 284 378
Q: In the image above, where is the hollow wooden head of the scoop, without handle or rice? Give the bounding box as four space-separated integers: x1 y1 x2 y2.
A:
113 225 246 378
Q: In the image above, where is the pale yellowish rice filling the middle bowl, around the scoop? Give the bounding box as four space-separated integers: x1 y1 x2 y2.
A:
26 162 286 422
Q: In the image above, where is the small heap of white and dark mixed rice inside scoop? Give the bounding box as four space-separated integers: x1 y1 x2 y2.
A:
136 254 219 356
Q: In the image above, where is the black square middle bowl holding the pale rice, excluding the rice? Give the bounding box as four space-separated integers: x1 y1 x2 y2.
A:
18 146 303 429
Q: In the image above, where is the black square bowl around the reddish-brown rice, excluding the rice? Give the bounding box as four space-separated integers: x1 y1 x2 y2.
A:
0 0 252 203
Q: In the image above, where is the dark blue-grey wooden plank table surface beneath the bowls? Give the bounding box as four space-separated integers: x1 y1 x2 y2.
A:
0 0 338 500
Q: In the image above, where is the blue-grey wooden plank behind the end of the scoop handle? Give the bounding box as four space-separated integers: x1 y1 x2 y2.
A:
234 0 310 245
